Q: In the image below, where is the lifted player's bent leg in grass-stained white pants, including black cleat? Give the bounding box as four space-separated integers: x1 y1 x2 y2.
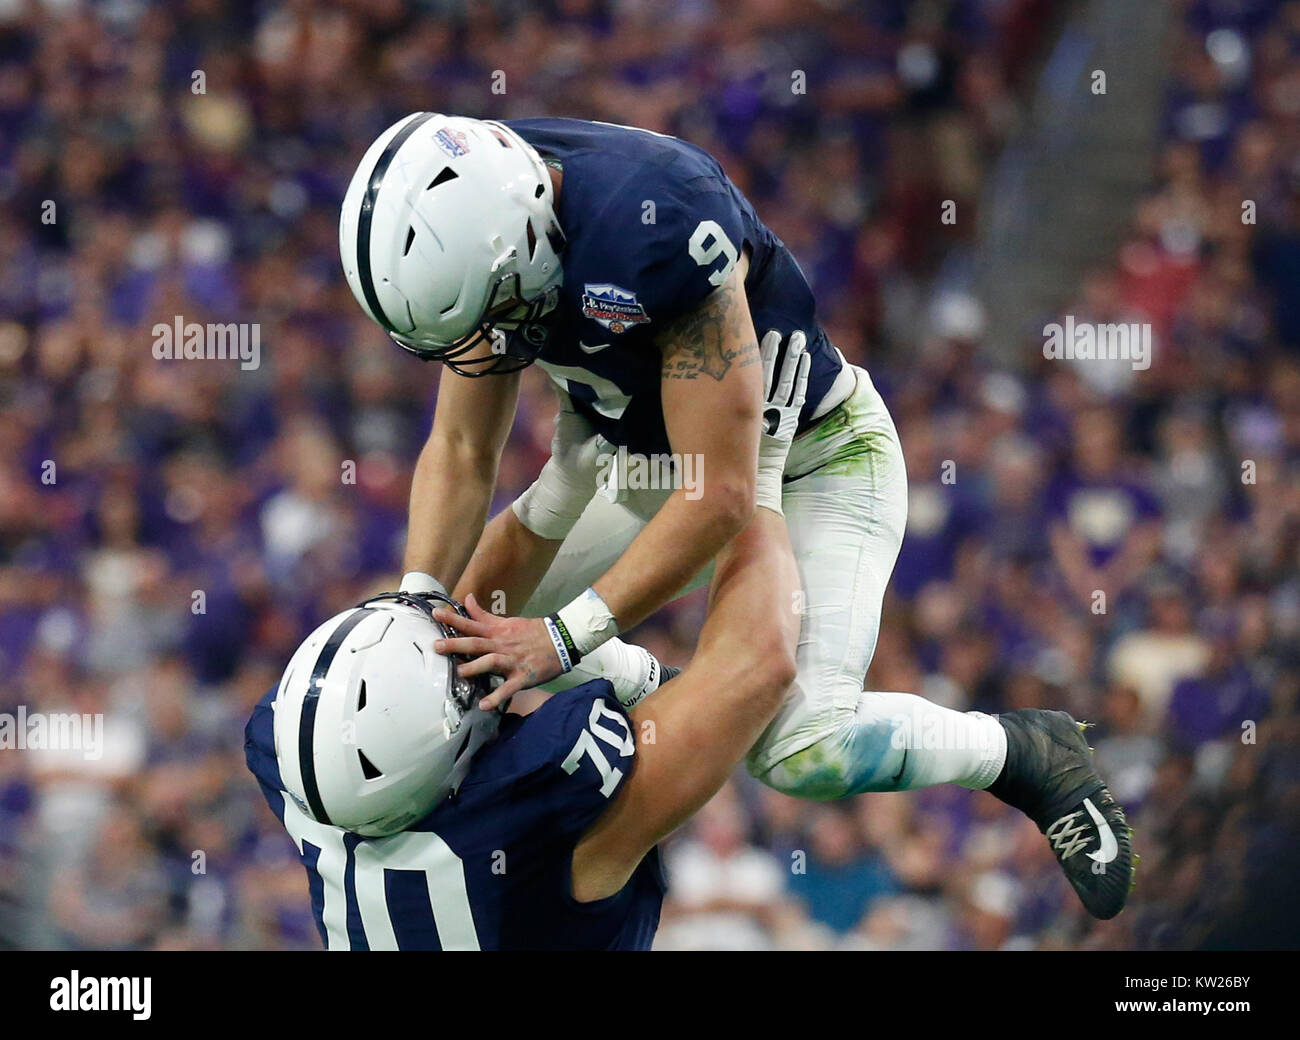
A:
748 373 1134 918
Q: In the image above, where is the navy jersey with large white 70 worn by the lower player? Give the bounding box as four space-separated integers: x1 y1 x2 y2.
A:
244 679 664 950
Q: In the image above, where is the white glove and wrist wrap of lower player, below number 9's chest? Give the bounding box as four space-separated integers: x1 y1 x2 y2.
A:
512 390 614 541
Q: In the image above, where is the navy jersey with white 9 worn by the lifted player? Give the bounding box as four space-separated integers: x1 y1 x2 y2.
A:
507 120 842 455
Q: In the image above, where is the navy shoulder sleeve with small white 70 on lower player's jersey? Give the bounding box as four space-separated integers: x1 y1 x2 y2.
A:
463 679 636 839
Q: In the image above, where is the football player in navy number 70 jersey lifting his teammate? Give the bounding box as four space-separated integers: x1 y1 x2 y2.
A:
246 335 807 950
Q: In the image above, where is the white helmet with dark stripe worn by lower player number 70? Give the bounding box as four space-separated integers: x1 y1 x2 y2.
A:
272 593 501 837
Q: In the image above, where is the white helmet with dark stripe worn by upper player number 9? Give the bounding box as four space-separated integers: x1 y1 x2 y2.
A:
338 112 564 376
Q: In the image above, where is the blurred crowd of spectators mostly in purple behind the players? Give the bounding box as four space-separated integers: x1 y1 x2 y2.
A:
0 0 1300 949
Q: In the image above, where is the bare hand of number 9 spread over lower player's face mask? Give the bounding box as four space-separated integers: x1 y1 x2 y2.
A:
433 595 563 711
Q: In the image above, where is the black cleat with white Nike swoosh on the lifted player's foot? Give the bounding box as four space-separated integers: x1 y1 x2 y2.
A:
989 709 1134 920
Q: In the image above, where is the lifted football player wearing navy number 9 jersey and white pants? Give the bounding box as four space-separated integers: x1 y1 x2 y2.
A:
339 112 1132 918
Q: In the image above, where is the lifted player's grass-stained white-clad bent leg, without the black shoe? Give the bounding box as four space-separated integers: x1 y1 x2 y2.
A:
748 372 1006 800
